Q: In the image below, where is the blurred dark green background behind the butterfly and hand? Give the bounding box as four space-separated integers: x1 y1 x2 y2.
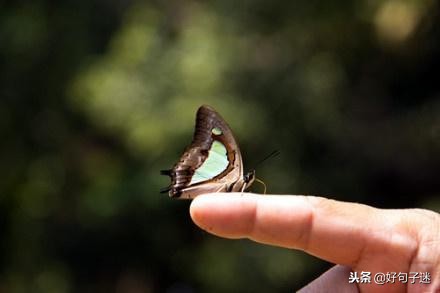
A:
0 0 440 293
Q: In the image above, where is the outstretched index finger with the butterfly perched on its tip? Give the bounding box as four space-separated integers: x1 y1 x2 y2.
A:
190 193 415 268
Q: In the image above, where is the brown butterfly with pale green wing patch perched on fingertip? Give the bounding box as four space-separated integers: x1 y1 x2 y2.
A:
161 105 255 199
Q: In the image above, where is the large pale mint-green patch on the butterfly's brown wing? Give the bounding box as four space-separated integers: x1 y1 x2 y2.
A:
190 140 229 185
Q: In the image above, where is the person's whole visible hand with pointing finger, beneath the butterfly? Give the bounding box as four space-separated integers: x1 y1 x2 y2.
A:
190 193 440 292
